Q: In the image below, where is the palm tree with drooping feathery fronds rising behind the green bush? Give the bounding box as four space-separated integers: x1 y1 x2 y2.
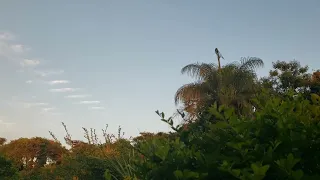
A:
175 52 263 118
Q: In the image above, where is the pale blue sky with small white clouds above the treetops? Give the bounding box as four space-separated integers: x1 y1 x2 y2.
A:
0 0 320 140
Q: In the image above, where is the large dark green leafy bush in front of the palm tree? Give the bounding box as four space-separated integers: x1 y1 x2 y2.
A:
135 94 320 180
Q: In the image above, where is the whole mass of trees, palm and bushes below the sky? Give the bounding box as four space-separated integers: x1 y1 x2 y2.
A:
0 50 320 180
